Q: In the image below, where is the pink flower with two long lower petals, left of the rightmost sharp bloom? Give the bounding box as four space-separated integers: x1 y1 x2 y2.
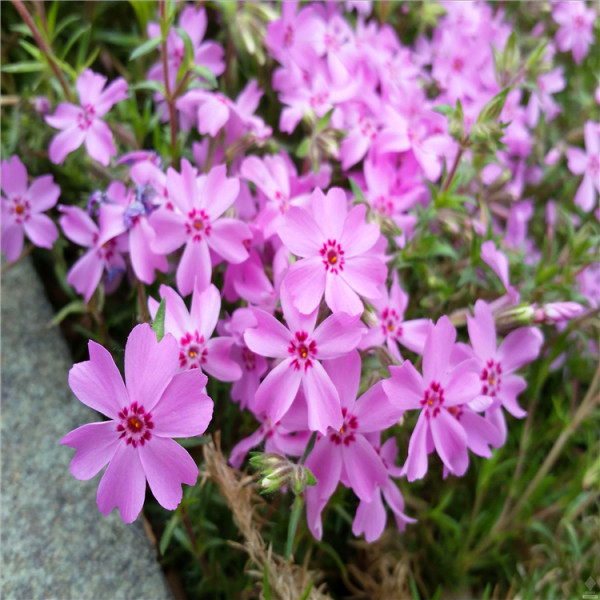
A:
383 316 481 481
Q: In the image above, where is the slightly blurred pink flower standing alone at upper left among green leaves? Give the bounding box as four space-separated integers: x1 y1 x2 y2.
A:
46 69 127 166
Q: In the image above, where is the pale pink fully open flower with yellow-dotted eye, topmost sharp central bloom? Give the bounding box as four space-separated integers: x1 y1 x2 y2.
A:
278 188 387 315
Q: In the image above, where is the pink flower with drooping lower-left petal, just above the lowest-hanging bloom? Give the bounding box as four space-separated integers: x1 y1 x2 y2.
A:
306 352 402 539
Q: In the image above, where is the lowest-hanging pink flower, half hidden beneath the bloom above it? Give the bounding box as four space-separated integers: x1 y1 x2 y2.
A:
352 437 417 543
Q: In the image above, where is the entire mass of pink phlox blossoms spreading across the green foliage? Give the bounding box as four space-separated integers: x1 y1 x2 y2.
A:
2 2 600 541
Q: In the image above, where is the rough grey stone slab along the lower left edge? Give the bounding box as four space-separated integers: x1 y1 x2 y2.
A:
0 261 172 600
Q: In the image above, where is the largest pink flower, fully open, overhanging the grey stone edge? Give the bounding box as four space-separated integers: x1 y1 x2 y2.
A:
60 324 213 523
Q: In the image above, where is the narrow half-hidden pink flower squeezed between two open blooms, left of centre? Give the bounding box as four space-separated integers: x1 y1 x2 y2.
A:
217 308 267 409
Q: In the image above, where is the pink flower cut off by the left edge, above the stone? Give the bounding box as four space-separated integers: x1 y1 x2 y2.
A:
0 156 60 262
